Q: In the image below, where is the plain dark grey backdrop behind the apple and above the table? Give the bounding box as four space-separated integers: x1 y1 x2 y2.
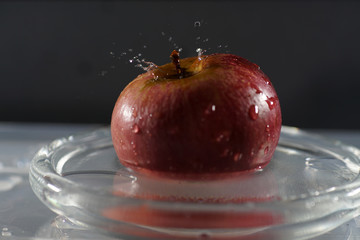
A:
0 1 360 129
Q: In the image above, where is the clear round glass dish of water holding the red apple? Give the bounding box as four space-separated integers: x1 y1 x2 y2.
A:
30 127 360 240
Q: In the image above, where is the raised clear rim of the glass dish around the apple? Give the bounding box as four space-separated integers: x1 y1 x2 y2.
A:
29 126 360 210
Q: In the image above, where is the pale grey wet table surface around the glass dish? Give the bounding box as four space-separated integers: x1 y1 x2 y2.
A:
0 123 360 240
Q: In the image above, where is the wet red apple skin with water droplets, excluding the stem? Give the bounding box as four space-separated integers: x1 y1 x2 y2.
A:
111 54 281 178
